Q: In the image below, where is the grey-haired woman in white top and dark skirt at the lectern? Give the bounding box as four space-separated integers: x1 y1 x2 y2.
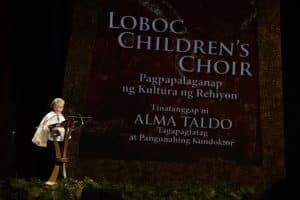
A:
32 98 65 179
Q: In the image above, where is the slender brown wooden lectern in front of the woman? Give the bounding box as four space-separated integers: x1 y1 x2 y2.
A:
46 117 87 185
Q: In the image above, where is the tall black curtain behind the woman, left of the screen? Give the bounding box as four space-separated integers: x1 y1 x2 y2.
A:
6 0 73 178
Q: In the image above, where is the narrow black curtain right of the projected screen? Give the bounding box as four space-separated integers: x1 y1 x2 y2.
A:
281 0 300 183
